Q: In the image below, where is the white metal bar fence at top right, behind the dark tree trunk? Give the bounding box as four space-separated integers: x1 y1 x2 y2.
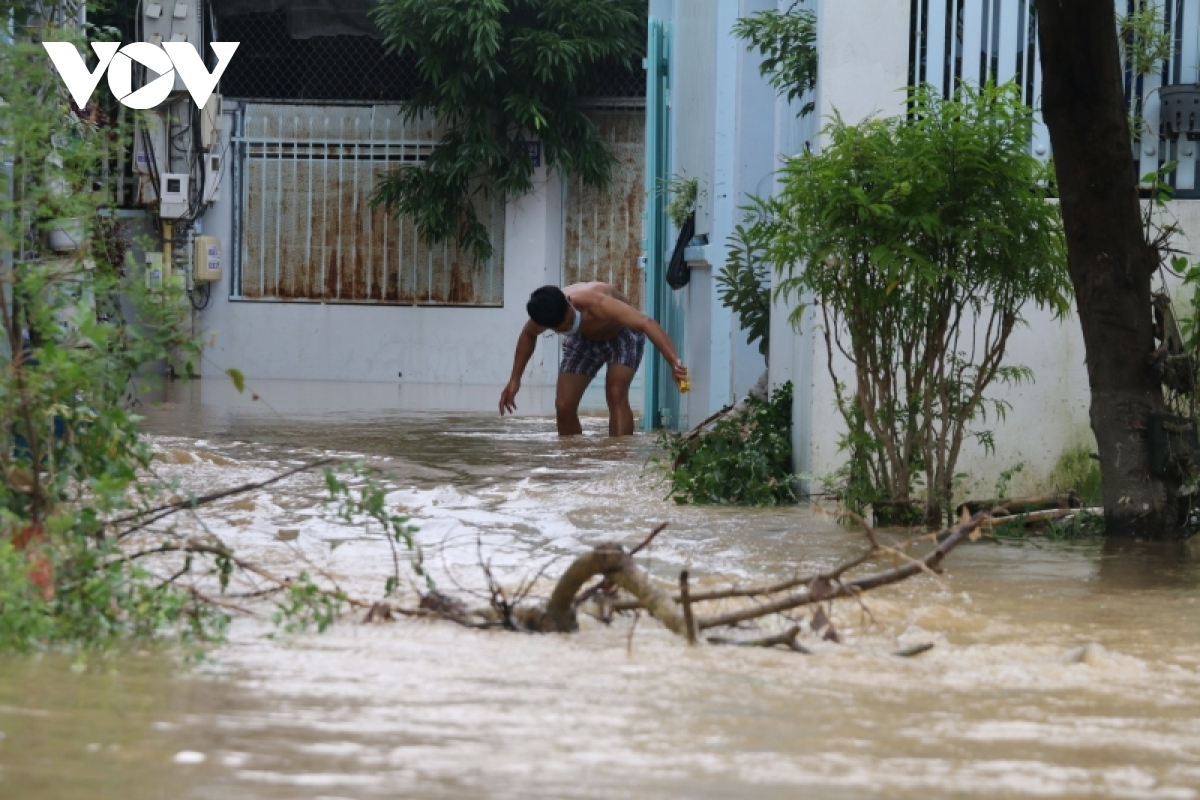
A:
908 0 1200 190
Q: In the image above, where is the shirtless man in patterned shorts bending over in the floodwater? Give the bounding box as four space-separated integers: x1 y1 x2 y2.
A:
500 282 688 437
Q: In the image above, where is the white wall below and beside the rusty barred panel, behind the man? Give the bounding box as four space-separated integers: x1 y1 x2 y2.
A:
200 107 566 414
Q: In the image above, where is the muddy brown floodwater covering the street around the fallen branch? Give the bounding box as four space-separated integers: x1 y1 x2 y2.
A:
0 383 1200 800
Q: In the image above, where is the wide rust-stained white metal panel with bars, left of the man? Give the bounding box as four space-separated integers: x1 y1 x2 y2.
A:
234 103 504 306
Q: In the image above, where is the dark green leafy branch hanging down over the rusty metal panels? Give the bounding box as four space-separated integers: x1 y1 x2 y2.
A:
373 0 646 260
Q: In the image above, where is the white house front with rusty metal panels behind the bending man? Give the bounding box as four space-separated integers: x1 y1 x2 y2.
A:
151 6 646 414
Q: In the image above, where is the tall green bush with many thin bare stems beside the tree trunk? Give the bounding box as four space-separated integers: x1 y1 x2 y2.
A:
750 84 1070 524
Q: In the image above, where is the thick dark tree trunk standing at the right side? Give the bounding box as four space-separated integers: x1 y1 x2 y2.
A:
1037 0 1180 539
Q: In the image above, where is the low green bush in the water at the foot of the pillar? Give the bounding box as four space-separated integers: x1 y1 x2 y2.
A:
660 381 797 506
